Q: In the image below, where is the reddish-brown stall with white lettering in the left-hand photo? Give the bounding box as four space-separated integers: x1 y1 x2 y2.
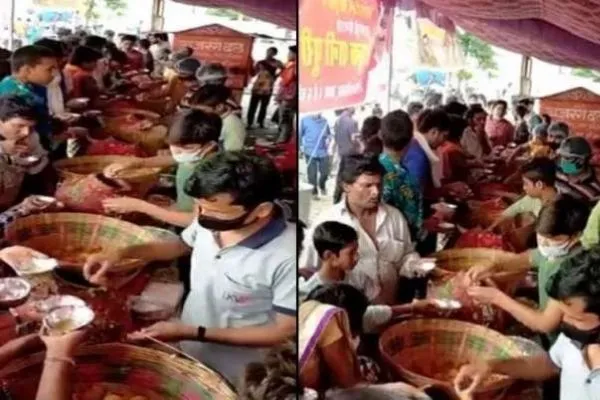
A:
173 24 254 102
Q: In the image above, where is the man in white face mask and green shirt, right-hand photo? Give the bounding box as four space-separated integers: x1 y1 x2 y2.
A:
468 195 590 347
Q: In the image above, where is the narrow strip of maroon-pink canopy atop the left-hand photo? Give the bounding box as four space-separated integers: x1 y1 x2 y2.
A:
175 0 298 30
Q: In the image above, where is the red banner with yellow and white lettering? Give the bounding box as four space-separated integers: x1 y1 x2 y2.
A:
299 0 393 113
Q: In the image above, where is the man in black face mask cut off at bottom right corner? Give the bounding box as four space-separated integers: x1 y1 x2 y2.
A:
455 249 600 400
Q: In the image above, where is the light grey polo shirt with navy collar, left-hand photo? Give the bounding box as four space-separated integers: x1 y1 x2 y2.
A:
181 218 297 384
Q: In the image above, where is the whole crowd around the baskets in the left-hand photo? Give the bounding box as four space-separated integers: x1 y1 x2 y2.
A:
0 26 297 400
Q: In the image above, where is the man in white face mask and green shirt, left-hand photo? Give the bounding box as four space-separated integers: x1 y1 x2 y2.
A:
104 110 222 227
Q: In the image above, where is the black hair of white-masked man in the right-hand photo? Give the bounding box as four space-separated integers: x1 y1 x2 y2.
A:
535 194 590 236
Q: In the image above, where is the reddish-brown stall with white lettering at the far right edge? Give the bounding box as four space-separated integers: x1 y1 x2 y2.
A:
540 87 600 166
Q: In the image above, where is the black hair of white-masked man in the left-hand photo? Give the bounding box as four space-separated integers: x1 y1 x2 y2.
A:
167 110 223 146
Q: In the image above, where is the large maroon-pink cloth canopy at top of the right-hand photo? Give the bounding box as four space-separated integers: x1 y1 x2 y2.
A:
399 0 600 69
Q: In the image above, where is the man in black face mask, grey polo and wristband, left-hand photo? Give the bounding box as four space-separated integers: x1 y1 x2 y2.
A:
84 152 297 382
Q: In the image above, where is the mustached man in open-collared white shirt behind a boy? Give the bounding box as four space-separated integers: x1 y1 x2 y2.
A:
300 155 419 305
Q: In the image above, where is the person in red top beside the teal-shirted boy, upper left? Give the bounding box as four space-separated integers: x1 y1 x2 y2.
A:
64 46 102 103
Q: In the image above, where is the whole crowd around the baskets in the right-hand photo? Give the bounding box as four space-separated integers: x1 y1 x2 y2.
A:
298 98 600 400
